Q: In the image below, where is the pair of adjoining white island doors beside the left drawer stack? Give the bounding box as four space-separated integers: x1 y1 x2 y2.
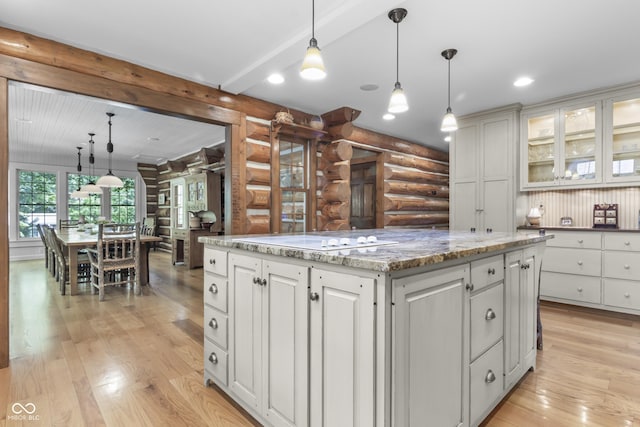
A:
228 254 308 426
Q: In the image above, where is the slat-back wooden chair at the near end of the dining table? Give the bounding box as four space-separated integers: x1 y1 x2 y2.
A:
87 223 140 301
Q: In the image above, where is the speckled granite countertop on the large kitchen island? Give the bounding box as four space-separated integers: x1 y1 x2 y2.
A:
198 229 553 272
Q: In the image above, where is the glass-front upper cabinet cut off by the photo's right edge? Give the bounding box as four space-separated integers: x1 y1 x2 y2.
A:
604 93 640 183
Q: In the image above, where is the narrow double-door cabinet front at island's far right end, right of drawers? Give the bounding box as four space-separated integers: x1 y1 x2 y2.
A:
504 248 536 388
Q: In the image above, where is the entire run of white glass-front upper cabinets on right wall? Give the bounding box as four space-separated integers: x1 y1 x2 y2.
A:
520 88 640 190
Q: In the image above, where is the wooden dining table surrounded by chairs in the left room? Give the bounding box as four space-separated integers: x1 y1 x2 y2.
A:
55 228 162 295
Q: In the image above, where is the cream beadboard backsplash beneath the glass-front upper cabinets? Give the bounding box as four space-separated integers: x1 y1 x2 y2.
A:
518 187 640 230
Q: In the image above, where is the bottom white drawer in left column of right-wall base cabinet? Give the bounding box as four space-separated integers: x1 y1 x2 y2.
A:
540 271 601 304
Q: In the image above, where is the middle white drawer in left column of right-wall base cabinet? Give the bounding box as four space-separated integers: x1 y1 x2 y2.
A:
542 247 602 276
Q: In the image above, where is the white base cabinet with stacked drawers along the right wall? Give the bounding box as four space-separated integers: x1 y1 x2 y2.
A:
540 231 640 314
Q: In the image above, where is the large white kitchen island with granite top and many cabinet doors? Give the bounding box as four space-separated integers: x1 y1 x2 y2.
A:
200 229 552 427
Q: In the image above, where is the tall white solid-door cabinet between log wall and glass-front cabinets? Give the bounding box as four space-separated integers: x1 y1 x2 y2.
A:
450 106 519 231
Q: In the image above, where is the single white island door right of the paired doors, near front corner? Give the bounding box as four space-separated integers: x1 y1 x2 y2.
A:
309 268 375 427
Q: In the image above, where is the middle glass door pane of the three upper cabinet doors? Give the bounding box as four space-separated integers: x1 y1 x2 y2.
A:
563 105 596 180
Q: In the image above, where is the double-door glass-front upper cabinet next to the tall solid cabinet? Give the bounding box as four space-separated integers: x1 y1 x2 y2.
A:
521 102 602 189
